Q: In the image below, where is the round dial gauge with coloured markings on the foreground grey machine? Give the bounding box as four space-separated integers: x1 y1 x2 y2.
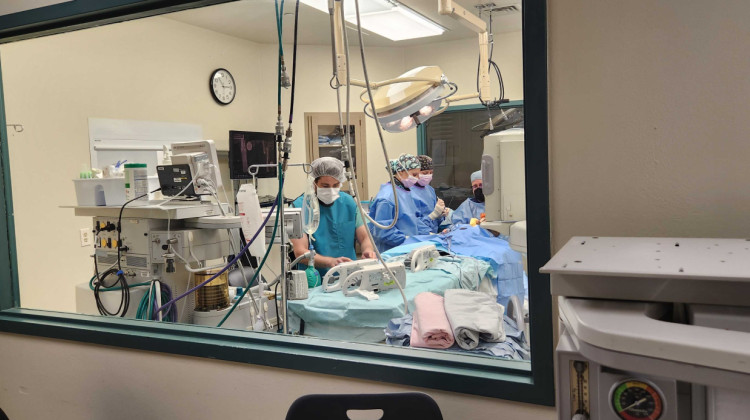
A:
611 379 664 420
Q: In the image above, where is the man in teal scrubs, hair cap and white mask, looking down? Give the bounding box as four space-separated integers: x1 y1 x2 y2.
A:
291 157 375 276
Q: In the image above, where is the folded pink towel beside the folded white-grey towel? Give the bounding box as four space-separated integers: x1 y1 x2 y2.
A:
410 292 454 349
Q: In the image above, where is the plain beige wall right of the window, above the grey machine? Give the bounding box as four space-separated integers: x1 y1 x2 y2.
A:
549 0 750 248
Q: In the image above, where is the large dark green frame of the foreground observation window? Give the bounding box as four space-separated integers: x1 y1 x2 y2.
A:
0 0 554 406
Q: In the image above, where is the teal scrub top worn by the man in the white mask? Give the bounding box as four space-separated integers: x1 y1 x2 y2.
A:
292 191 364 278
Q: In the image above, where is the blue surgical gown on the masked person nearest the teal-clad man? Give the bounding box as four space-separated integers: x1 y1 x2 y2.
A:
369 182 421 251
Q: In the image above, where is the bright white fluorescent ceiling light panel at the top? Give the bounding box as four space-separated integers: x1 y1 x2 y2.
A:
301 0 445 41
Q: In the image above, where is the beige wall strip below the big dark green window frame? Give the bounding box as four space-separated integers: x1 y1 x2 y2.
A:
0 334 555 420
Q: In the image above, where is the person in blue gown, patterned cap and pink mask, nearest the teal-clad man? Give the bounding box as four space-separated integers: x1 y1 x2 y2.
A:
370 153 422 251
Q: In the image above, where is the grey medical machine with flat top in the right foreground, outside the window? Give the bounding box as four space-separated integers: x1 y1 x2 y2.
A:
541 237 750 420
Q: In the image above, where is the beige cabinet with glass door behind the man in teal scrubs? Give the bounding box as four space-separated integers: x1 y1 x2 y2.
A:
305 112 370 200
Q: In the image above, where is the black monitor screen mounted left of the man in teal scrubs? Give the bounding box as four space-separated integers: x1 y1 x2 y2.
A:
229 131 277 179
